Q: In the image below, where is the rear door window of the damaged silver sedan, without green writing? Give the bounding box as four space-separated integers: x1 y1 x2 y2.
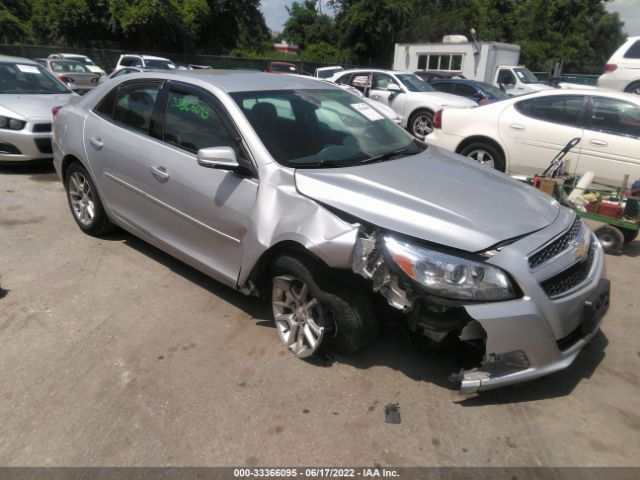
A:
113 82 161 133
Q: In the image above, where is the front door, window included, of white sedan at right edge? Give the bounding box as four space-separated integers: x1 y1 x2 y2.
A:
576 97 640 185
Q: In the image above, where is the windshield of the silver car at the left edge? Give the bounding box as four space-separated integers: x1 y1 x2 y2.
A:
0 63 71 94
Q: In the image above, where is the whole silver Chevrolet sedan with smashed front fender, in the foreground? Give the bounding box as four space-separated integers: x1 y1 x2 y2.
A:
54 70 609 392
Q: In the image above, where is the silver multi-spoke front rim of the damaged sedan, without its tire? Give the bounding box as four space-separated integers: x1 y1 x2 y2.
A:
272 275 326 358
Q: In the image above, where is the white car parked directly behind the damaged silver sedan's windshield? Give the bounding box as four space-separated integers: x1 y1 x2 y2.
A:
330 69 478 139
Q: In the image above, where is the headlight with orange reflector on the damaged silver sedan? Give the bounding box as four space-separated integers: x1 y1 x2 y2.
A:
384 236 515 300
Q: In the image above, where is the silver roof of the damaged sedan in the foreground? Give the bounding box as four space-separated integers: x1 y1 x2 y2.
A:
127 69 338 93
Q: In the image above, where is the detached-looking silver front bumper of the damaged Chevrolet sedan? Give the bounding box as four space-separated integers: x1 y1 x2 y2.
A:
456 213 609 393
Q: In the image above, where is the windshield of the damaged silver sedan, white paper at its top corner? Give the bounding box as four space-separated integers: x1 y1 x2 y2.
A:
231 89 424 168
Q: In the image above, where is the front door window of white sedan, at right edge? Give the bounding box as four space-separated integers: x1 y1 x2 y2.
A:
589 97 640 138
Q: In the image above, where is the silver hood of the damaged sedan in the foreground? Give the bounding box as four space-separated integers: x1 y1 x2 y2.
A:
295 146 560 252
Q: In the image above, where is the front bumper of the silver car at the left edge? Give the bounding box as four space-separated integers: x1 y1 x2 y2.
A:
0 117 53 163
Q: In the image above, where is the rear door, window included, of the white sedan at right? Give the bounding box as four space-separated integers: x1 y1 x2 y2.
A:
499 95 586 175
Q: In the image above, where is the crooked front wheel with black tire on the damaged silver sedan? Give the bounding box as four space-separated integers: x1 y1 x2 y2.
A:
271 254 378 358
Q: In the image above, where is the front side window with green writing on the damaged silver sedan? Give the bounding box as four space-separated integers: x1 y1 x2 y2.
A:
164 88 237 153
